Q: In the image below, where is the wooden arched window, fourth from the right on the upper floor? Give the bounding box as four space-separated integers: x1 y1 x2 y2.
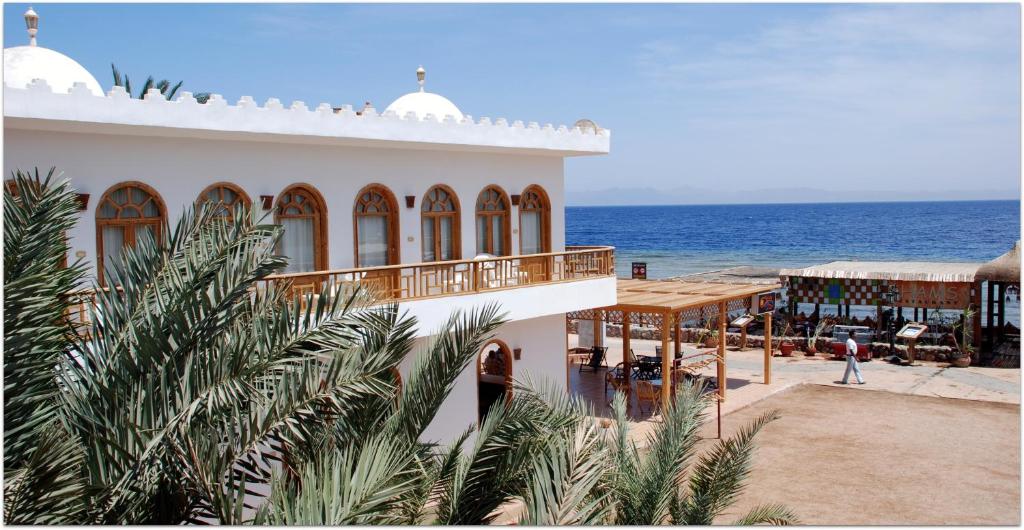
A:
352 184 398 267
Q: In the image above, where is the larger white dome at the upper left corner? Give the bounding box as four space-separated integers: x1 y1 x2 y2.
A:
3 46 103 96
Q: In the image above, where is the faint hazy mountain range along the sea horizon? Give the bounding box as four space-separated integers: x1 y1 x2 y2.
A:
565 187 1020 206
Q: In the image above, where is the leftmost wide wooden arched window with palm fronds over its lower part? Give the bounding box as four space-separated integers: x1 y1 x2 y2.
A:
96 182 167 284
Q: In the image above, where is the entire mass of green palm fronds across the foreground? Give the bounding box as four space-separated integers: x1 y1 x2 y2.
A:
4 170 795 525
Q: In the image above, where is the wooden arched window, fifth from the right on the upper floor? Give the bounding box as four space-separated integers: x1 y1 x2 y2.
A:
273 184 328 272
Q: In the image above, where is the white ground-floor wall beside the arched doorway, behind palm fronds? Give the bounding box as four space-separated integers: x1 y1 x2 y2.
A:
399 314 567 443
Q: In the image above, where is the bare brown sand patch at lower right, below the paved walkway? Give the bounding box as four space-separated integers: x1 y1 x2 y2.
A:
707 385 1021 525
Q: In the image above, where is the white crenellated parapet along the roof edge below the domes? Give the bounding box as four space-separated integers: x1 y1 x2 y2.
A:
4 79 611 156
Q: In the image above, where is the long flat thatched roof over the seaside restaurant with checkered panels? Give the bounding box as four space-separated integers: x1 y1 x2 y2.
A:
779 261 981 282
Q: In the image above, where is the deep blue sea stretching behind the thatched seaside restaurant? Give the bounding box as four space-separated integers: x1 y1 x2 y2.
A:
565 201 1021 326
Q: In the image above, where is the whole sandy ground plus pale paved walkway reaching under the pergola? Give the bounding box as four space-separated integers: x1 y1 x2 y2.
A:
557 336 1021 525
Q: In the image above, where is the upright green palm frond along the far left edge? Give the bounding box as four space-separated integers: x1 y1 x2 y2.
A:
3 169 84 470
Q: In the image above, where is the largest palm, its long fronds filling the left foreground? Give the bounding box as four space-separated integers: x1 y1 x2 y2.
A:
4 168 502 524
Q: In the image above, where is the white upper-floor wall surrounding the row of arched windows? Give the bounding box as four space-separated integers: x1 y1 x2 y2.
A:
4 127 565 278
